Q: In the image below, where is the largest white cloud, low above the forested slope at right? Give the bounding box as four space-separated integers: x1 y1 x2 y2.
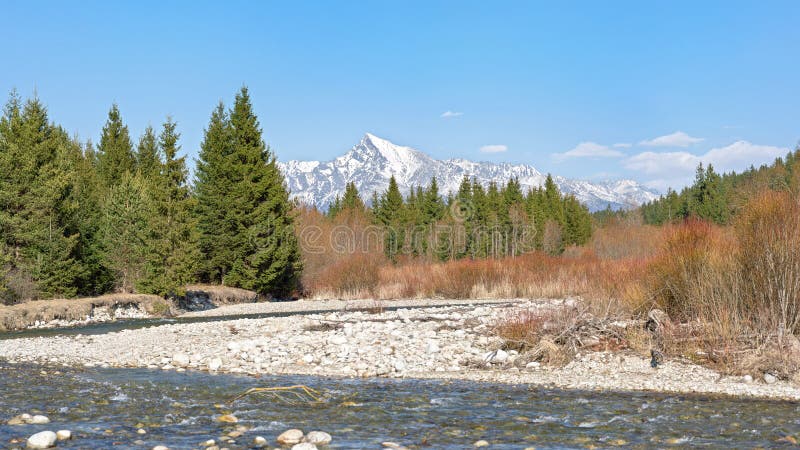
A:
623 141 789 190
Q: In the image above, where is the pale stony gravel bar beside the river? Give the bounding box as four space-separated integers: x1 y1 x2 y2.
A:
0 300 800 400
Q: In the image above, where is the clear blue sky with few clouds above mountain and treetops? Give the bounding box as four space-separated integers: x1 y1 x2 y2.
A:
0 1 800 189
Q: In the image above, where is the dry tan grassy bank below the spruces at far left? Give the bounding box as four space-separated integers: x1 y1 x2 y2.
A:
0 294 170 331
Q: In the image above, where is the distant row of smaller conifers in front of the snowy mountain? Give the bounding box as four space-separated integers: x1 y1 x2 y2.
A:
362 172 592 261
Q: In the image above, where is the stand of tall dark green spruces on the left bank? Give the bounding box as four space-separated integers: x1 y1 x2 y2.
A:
0 88 302 303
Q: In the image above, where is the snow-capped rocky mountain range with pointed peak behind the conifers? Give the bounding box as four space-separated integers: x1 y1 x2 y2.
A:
279 133 658 211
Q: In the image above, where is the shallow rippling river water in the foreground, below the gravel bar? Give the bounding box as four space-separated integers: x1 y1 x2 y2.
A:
0 363 800 449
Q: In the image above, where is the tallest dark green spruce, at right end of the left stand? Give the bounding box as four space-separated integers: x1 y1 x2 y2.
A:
198 87 302 296
